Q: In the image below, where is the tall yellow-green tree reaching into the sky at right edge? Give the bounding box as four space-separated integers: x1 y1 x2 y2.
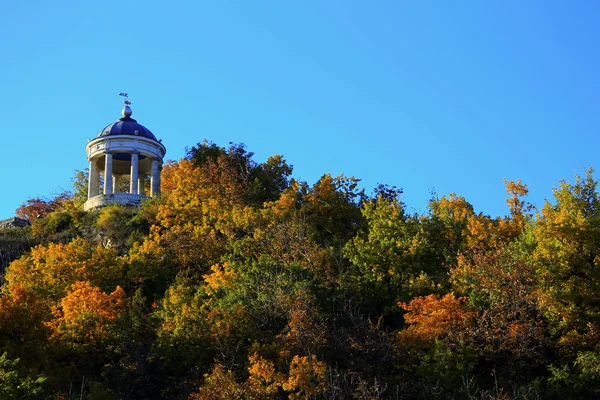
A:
533 169 600 335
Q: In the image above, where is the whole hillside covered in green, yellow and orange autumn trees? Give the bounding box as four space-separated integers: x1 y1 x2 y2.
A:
0 141 600 399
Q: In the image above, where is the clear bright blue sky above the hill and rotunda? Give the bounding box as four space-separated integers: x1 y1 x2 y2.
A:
0 0 600 219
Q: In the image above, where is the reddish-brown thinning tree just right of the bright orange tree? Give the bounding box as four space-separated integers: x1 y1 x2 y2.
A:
452 242 550 390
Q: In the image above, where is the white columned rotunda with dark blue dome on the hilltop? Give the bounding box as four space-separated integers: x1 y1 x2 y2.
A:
84 93 167 210
